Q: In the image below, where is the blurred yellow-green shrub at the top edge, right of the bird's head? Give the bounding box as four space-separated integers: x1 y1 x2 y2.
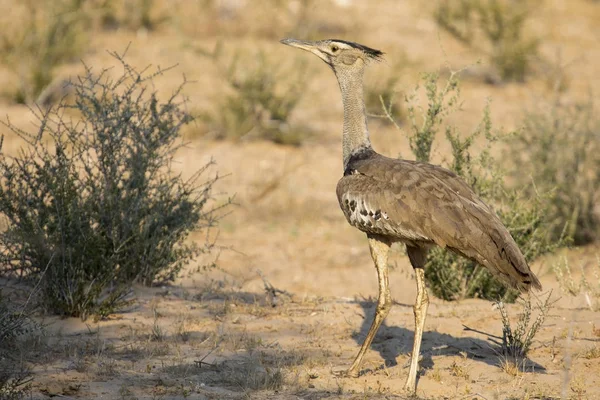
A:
434 0 539 82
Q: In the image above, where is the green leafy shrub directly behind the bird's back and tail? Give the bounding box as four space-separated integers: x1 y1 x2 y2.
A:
386 73 564 302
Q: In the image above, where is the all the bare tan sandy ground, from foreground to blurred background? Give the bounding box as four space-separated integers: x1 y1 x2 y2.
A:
0 0 600 399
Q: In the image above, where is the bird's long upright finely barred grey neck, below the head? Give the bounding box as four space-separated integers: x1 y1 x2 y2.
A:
337 69 371 170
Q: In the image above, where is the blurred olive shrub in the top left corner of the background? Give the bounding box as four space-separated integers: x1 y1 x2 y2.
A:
0 0 86 103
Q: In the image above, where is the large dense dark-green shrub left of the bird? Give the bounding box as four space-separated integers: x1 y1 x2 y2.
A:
0 50 227 318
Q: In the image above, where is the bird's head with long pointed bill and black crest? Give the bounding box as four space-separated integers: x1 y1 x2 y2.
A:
281 39 383 73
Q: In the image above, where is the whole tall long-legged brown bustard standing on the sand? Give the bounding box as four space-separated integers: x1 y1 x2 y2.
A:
281 39 542 393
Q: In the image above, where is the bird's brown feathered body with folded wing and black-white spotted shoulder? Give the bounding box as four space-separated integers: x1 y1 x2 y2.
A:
337 154 541 290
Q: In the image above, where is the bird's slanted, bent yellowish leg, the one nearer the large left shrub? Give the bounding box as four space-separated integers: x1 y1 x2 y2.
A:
346 236 392 376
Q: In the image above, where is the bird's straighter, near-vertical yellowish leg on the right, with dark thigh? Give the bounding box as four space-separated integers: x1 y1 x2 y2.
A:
404 246 429 393
